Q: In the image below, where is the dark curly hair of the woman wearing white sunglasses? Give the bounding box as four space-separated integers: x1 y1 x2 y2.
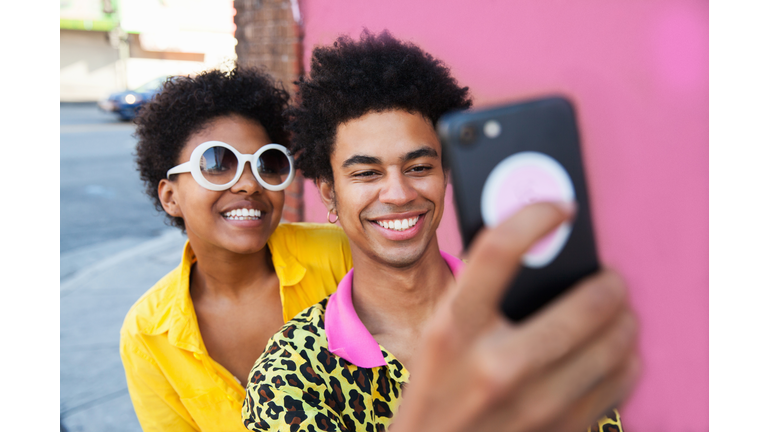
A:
134 65 289 231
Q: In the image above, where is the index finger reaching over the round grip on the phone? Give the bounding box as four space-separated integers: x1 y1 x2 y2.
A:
452 202 572 335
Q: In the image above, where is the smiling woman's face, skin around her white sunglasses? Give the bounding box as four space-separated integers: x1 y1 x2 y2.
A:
159 115 285 254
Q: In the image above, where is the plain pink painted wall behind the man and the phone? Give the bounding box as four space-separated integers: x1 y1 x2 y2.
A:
301 0 709 432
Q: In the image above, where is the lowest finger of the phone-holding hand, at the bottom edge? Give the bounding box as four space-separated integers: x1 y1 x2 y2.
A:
551 351 641 432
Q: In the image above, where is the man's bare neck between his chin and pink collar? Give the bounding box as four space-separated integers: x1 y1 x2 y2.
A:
352 238 453 339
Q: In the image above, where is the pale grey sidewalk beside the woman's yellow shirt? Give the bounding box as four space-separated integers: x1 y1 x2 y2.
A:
60 230 186 432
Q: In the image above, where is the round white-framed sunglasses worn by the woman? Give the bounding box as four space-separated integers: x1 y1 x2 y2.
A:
166 141 296 191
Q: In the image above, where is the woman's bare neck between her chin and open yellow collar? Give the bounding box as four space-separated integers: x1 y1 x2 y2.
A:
189 236 274 298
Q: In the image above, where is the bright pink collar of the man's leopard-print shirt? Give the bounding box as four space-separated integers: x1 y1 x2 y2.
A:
325 251 464 368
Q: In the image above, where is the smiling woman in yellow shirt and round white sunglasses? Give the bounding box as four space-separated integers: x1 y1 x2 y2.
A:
120 67 352 431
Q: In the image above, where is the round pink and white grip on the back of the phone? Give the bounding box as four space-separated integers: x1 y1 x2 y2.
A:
480 152 575 268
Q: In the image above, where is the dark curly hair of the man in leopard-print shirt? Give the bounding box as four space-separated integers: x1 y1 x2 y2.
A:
287 29 472 184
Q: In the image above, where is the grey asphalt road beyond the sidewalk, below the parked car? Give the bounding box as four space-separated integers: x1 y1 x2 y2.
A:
60 104 169 277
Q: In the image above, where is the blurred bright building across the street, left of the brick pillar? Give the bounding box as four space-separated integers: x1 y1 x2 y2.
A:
60 0 237 102
